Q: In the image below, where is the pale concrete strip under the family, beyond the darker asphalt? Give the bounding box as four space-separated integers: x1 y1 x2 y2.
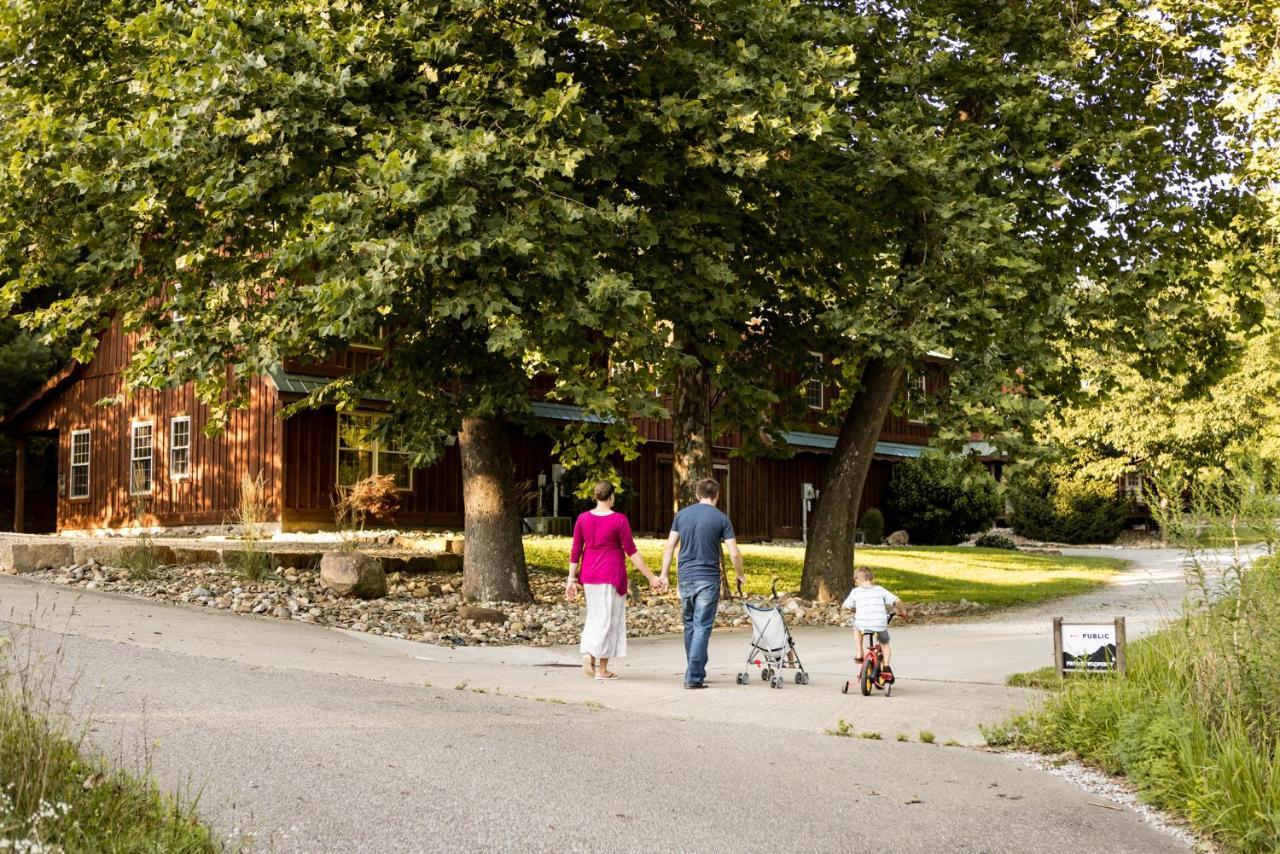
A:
0 549 1187 744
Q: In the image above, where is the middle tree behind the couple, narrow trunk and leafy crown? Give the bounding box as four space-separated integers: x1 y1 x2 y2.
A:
565 0 856 503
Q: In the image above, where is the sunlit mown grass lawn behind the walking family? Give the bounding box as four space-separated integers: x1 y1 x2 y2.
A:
525 538 1125 607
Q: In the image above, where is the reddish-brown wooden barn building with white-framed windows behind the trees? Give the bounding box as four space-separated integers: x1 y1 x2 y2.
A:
0 325 945 540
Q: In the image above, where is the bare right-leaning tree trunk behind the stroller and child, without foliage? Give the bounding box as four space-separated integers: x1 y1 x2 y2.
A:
800 359 906 602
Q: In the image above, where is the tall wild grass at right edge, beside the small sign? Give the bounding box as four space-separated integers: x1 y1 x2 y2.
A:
988 458 1280 854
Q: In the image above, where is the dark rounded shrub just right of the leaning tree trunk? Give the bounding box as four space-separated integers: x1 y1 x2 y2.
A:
886 453 1001 545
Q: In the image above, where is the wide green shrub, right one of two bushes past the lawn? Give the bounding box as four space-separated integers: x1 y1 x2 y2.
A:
1009 465 1130 543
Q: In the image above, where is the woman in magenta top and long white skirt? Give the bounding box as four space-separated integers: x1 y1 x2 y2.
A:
564 480 664 679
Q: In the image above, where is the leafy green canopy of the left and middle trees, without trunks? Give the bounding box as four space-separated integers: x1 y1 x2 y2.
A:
0 0 856 473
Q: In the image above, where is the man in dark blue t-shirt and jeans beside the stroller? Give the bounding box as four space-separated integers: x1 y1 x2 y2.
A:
662 478 746 688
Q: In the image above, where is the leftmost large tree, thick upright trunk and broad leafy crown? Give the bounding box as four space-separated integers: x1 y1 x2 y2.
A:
0 0 675 599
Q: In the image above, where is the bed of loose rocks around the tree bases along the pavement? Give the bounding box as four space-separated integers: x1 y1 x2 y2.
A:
27 562 982 647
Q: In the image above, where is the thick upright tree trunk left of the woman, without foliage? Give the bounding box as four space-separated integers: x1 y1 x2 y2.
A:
458 419 534 602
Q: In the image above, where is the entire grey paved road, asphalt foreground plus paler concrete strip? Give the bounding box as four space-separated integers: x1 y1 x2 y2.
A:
0 552 1184 851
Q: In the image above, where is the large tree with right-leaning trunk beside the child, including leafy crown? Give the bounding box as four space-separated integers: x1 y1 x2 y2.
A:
803 0 1254 599
